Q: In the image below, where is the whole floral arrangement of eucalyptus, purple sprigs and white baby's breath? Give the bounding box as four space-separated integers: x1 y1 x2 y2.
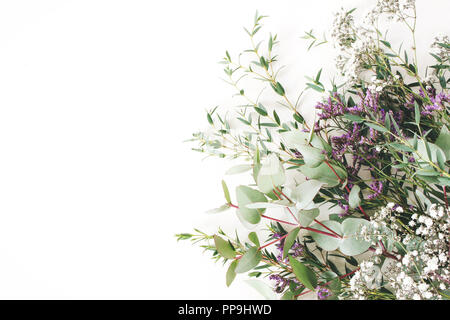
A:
177 0 450 300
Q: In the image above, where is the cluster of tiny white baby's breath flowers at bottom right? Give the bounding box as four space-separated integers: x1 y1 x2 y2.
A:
341 203 450 300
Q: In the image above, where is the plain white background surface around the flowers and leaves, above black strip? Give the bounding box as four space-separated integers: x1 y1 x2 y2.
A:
0 0 450 299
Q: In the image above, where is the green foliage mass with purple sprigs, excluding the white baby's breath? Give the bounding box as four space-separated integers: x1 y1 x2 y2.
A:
184 4 450 300
